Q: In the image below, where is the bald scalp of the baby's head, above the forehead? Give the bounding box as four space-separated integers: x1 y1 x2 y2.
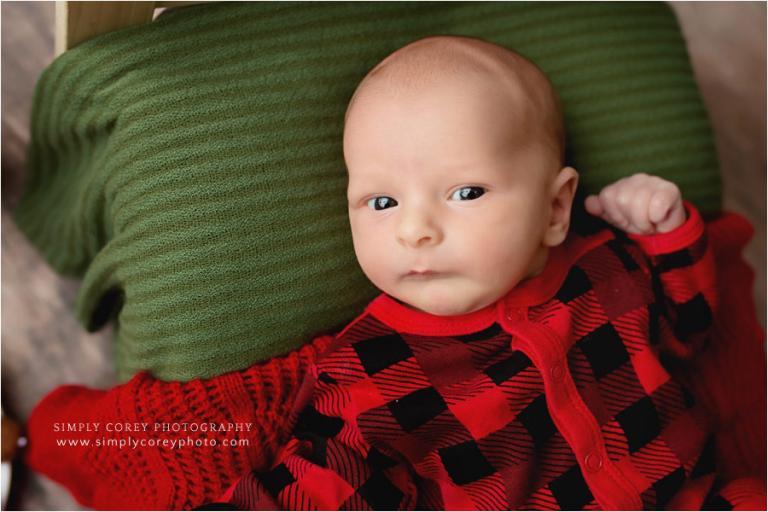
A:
345 36 565 165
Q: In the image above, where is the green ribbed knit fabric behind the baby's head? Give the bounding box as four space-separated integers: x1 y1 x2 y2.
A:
17 2 720 380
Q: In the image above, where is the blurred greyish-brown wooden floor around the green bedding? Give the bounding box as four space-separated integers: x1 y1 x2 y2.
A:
0 2 766 510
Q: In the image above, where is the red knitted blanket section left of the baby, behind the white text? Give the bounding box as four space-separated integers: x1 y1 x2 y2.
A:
26 337 331 510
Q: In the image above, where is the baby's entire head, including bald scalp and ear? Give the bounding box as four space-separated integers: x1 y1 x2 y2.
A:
344 36 577 315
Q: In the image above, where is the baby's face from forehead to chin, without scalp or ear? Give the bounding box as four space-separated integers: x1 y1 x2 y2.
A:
344 76 560 315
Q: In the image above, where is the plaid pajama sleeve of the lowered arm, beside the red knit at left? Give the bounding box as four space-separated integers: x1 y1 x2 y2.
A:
216 362 417 510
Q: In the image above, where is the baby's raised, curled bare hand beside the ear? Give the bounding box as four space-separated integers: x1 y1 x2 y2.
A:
584 173 685 235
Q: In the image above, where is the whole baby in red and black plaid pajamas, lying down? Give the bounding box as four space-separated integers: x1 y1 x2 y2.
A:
198 37 760 510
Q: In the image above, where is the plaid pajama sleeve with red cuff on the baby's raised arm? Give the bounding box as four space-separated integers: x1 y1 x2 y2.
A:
630 202 717 359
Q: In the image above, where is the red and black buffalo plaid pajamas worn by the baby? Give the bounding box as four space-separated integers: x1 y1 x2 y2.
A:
210 205 736 510
